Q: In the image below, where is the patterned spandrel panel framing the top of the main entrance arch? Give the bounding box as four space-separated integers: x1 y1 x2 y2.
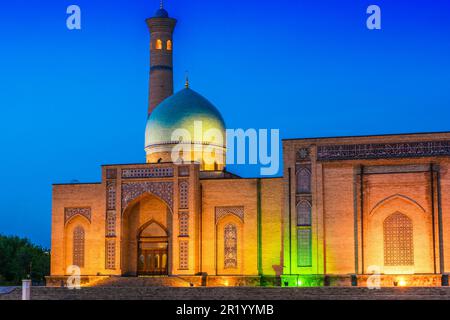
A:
122 182 173 212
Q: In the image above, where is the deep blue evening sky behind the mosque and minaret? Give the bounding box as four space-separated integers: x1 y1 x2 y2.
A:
0 0 450 247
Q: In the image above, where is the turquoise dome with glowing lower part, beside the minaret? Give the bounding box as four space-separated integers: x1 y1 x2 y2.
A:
145 88 226 148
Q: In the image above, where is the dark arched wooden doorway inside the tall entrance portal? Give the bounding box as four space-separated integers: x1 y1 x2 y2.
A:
137 221 169 275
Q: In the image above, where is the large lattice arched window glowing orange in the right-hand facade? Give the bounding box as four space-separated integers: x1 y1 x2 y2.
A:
383 212 414 266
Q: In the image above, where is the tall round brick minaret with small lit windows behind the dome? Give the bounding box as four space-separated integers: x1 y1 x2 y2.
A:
146 0 177 115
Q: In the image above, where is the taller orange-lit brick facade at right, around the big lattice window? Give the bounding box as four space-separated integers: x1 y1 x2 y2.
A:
284 133 450 280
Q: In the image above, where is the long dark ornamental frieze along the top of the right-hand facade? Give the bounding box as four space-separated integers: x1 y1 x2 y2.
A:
317 141 450 161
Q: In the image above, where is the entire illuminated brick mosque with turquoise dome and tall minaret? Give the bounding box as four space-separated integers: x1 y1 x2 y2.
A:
47 2 450 286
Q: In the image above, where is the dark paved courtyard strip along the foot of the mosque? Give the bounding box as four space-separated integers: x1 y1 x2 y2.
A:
0 287 450 301
